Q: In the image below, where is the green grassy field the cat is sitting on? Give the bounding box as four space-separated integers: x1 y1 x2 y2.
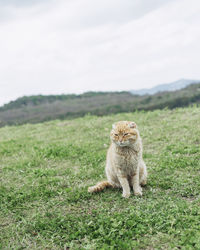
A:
0 107 200 249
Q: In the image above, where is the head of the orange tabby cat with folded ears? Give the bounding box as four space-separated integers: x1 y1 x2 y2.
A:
110 121 139 147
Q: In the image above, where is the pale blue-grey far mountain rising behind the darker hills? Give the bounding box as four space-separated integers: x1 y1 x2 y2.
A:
130 79 200 95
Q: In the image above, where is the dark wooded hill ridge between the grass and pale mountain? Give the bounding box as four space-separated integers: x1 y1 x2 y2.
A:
0 83 200 126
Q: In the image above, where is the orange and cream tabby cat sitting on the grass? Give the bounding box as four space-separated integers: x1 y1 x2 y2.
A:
88 121 147 198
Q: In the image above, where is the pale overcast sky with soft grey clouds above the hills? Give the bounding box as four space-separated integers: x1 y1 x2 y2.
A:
0 0 200 105
